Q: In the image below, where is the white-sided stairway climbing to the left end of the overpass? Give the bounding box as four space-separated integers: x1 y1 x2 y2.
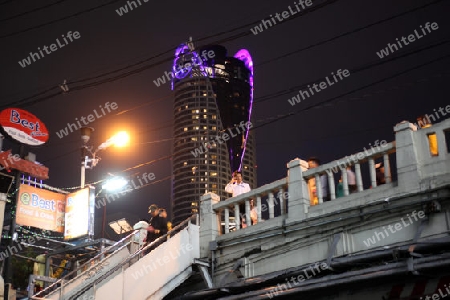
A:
32 222 200 300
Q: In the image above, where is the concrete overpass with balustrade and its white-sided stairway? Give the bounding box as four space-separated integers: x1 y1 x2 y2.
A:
33 119 450 300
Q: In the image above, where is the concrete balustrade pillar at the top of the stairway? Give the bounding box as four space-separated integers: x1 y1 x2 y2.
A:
200 193 220 257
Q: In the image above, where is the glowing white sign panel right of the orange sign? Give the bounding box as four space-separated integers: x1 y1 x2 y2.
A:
64 187 95 240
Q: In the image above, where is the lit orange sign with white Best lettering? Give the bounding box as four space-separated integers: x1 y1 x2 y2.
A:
16 184 66 233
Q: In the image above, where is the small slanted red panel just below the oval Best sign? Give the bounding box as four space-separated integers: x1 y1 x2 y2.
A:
0 150 48 180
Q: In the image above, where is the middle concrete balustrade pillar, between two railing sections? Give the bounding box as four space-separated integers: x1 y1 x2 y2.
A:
286 158 310 223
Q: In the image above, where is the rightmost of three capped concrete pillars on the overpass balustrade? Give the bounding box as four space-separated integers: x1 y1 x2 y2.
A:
394 121 421 192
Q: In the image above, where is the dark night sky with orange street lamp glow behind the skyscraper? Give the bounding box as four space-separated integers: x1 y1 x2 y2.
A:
0 0 450 236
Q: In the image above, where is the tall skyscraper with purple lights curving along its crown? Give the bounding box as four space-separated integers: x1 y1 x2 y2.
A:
172 42 256 224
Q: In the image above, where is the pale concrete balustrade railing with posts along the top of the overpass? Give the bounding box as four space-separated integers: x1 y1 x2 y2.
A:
200 119 450 255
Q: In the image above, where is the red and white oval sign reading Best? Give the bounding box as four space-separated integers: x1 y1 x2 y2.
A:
0 108 49 146
